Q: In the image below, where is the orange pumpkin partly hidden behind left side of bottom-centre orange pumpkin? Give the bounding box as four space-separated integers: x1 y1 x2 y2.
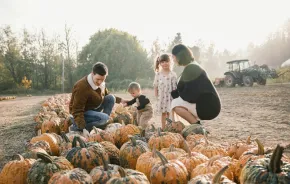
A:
136 146 160 178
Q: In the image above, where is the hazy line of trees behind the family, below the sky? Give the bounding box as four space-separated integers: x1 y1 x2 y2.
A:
0 20 290 93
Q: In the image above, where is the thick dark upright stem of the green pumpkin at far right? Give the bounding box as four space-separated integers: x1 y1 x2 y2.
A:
269 144 284 173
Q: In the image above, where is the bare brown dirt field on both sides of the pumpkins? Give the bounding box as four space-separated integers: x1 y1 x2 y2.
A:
0 85 290 170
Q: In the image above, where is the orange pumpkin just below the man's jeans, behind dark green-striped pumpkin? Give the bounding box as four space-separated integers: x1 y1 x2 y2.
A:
89 127 115 144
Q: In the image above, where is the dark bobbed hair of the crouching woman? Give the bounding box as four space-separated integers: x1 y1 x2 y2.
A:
172 44 194 66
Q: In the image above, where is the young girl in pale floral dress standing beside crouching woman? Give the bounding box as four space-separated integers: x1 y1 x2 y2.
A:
153 54 177 129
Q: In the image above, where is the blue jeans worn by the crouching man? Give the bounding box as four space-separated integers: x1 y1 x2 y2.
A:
70 95 116 131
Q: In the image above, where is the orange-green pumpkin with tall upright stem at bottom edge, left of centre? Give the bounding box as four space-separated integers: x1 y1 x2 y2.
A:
90 152 121 183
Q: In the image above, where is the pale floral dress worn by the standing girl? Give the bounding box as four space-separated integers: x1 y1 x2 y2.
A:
153 71 177 114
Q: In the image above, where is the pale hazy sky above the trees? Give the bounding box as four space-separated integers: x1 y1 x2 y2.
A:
0 0 290 50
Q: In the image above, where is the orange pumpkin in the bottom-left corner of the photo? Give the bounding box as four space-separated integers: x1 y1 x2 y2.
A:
0 155 35 184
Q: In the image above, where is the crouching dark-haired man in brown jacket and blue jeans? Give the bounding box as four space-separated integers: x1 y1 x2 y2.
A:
69 62 126 131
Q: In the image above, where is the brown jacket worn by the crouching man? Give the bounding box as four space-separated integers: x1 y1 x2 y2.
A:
69 76 121 129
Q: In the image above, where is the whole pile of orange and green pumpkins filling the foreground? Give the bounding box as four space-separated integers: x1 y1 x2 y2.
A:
0 96 290 184
